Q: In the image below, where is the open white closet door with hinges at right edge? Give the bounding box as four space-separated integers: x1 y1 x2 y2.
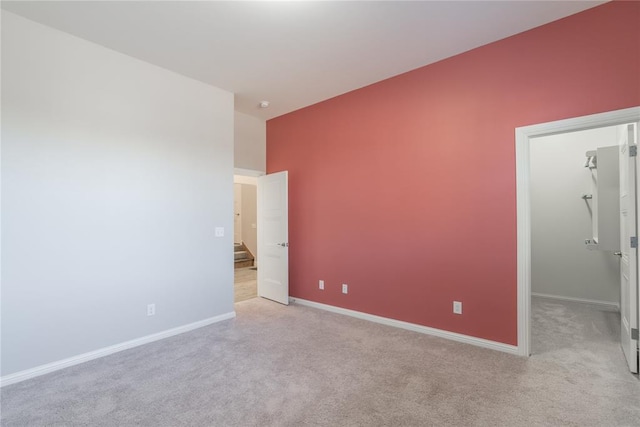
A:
618 124 640 373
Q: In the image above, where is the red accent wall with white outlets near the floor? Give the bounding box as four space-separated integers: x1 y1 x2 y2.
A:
267 2 640 345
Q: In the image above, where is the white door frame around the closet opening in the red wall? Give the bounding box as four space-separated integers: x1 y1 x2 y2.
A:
515 107 640 357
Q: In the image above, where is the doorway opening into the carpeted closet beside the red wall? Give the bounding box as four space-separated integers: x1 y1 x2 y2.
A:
529 126 622 364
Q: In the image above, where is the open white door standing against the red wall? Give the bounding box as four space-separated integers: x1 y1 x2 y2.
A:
258 171 289 305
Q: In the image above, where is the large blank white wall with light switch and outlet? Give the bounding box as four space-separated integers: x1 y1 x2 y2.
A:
1 12 234 376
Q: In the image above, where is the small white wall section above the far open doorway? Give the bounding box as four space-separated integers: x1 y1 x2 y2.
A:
234 111 267 172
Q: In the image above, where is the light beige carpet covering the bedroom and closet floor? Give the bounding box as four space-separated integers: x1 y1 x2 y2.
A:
1 298 640 427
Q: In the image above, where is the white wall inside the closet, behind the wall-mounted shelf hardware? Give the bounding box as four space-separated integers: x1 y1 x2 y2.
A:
531 126 620 304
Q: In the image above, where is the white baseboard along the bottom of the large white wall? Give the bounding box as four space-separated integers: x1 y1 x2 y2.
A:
0 311 236 387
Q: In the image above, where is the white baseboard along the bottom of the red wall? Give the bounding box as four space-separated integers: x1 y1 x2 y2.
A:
292 298 518 355
